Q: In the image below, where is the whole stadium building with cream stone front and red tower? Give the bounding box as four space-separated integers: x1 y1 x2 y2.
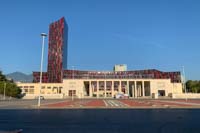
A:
18 17 182 99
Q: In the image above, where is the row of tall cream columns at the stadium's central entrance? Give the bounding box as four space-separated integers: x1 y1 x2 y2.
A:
88 80 150 98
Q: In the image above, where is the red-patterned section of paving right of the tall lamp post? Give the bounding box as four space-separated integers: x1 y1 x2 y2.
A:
42 99 200 108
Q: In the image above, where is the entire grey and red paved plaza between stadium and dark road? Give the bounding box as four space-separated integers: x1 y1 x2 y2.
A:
0 99 200 109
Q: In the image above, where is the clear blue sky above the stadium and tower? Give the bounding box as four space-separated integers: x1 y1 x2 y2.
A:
0 0 200 80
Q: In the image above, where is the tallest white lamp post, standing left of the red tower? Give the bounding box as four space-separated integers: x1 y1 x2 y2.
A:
38 33 47 107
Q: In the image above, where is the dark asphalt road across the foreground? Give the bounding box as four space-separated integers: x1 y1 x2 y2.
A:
0 109 200 133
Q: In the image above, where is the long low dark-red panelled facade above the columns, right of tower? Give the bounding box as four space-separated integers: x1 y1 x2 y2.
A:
63 69 181 83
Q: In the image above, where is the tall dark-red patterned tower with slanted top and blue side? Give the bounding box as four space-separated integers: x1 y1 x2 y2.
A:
47 17 68 83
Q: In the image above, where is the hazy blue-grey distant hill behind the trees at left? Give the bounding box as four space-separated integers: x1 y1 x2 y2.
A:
6 72 33 82
